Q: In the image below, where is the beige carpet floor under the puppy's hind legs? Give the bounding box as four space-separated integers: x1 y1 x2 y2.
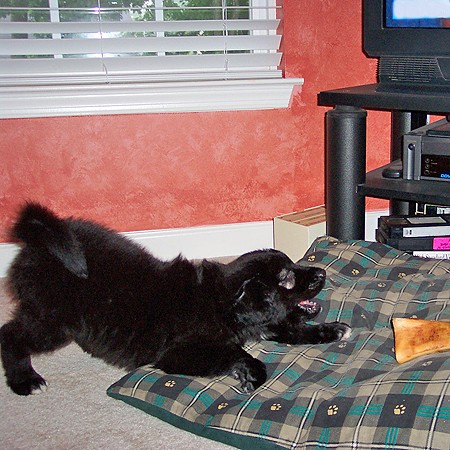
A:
0 279 232 450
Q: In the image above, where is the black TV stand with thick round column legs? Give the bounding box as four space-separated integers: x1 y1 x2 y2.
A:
319 84 450 240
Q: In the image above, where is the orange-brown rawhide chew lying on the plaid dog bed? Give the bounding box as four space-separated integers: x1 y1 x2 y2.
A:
392 318 450 364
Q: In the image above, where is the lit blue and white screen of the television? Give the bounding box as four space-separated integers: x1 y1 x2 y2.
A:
386 0 450 28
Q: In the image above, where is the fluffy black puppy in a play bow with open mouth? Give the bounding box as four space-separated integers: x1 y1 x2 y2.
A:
0 203 351 395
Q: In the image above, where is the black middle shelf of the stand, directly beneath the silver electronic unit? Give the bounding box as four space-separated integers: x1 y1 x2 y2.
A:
357 164 450 205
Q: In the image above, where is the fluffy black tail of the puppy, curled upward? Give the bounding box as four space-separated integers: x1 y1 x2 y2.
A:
11 203 88 278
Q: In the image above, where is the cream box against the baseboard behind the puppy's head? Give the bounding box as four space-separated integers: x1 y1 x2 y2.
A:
273 206 326 262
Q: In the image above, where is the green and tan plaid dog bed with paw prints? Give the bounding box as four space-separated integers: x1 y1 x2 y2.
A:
108 238 450 450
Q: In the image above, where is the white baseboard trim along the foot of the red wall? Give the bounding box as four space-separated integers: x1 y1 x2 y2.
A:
0 211 388 277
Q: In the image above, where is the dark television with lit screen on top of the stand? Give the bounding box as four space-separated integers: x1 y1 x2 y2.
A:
363 0 450 92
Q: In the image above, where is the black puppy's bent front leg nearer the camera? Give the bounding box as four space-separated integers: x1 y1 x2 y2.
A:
154 342 267 393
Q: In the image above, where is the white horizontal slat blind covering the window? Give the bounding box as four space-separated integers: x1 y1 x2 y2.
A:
0 0 299 118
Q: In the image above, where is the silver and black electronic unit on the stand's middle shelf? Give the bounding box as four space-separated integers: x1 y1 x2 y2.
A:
403 118 450 181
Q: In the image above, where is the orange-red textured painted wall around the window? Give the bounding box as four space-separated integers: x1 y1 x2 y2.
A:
0 0 389 242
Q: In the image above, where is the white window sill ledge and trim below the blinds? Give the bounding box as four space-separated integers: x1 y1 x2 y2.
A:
0 78 304 119
